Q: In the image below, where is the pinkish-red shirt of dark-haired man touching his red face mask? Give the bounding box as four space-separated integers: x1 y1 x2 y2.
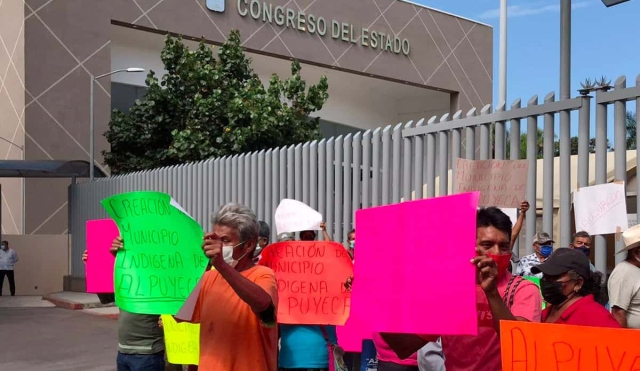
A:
442 272 542 371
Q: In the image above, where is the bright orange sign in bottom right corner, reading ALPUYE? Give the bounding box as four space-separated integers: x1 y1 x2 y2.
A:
500 321 640 371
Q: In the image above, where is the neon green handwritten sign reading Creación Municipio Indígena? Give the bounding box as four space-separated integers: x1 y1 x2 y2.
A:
101 192 208 315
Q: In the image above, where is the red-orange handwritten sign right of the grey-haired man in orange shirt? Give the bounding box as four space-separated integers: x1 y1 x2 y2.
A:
260 241 353 325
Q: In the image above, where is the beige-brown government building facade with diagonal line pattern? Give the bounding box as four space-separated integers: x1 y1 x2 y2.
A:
0 0 493 234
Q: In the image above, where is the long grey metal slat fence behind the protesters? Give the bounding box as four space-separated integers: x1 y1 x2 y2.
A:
69 76 640 276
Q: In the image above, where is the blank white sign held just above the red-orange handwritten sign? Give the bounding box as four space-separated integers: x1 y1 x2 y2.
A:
275 198 322 234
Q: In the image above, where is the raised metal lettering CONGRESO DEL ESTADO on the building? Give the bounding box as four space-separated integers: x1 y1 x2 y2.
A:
237 0 411 56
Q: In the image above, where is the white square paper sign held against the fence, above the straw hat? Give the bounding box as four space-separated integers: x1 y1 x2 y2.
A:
573 183 629 235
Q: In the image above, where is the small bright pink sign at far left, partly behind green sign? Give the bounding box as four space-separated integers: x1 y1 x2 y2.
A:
85 219 120 293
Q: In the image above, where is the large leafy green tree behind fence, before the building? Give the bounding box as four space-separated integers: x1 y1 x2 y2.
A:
102 30 329 174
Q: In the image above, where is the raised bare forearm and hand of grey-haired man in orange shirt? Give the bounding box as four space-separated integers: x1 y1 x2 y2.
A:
204 233 275 315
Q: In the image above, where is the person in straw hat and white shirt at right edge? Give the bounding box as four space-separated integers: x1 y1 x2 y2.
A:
608 225 640 329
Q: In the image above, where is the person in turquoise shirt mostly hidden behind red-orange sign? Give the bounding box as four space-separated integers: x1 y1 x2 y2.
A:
278 222 338 371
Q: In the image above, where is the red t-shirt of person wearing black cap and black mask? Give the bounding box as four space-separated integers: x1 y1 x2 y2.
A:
542 295 620 328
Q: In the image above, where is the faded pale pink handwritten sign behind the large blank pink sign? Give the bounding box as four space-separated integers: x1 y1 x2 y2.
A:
454 158 529 208
